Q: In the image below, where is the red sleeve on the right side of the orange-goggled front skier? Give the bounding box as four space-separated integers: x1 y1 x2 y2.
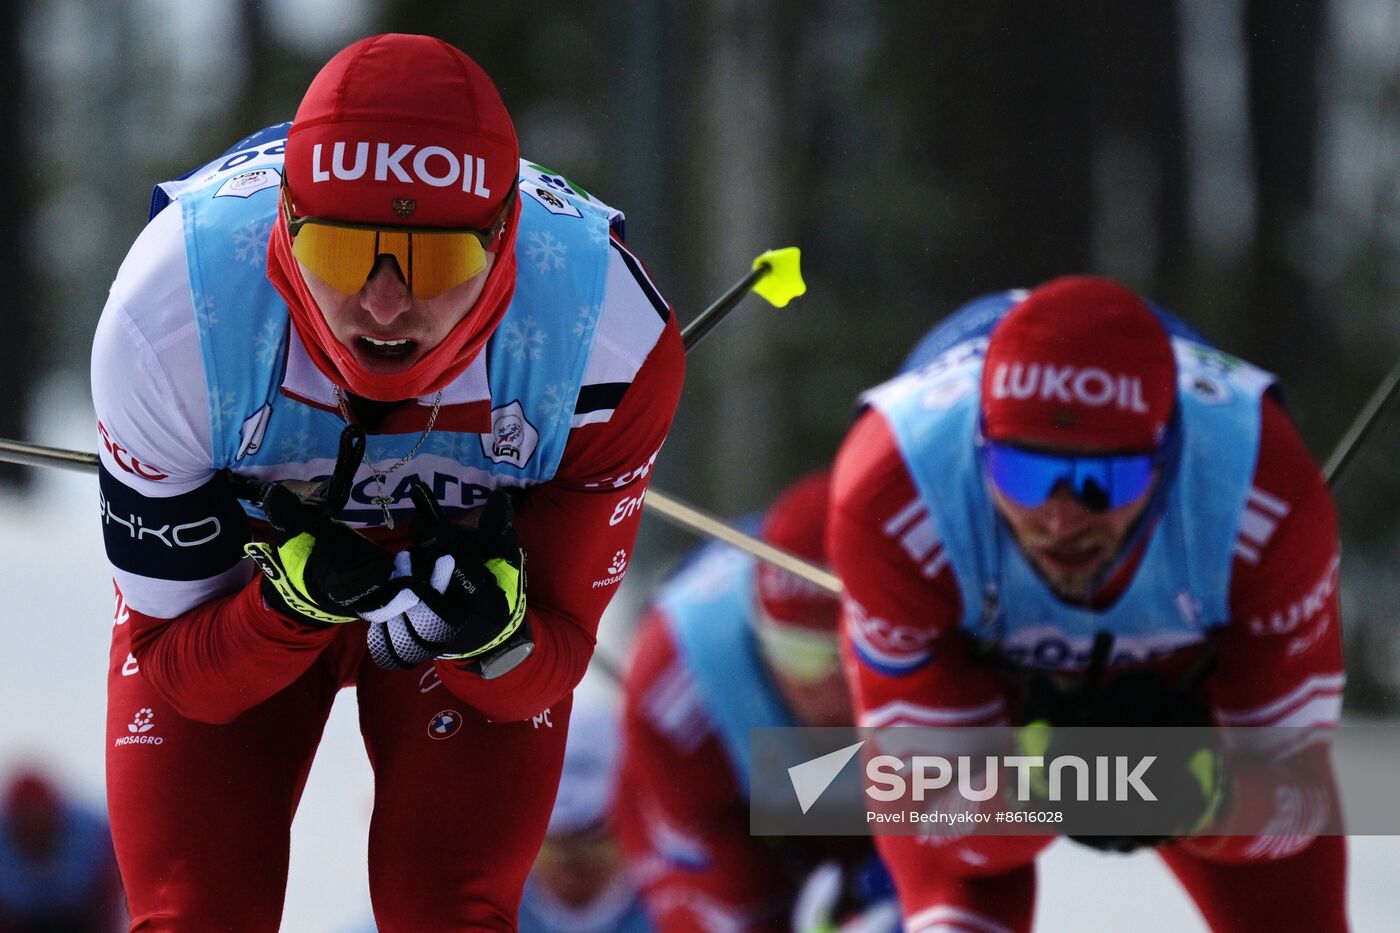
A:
437 314 685 721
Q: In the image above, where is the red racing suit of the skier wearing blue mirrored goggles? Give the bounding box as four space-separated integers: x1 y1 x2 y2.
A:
829 395 1345 933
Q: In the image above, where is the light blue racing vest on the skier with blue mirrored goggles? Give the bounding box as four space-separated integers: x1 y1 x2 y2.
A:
865 329 1273 670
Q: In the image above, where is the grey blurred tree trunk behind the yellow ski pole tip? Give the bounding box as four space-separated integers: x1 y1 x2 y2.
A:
673 0 794 514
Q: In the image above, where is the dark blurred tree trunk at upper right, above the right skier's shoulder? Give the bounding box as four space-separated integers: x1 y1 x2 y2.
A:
1245 0 1329 431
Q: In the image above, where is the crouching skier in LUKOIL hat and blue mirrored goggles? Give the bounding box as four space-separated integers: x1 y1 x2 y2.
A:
829 276 1347 933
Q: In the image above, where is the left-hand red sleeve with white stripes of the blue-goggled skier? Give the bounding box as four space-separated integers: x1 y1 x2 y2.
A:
827 410 1005 726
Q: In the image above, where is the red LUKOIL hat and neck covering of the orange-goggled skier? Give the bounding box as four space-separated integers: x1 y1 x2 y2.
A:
267 35 519 402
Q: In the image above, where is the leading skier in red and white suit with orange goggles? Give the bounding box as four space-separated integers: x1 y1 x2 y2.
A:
92 35 683 933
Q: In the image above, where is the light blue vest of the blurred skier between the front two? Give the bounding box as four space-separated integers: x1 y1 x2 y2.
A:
655 545 797 797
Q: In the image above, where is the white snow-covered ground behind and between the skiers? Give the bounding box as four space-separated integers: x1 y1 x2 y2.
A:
0 387 1400 933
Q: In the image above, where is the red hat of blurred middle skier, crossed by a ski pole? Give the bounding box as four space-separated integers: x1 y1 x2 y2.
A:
757 471 840 633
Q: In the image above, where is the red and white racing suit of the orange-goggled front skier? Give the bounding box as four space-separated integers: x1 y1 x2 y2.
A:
92 163 685 933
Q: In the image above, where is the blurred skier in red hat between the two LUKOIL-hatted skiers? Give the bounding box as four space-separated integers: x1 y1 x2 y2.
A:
617 471 889 932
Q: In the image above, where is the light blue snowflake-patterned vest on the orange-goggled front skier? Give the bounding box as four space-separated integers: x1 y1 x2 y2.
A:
153 125 620 524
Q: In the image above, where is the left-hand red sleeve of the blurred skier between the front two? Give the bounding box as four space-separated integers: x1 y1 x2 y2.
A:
616 612 791 933
